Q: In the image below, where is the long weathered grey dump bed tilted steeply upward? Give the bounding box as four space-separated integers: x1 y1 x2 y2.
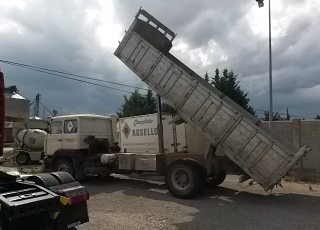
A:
115 10 307 190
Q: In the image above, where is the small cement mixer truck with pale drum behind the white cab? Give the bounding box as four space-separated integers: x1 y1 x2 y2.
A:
14 129 47 165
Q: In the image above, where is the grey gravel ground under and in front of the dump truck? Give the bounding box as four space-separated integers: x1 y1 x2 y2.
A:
79 174 320 230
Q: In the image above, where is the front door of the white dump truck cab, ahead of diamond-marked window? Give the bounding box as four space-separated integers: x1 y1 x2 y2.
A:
46 120 63 156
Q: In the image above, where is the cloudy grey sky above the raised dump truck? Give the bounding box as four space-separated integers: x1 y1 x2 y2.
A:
0 0 320 118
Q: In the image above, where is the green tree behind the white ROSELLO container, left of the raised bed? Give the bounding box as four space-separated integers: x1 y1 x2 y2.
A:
117 89 157 117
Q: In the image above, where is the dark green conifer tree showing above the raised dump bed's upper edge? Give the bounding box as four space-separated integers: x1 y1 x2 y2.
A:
210 69 255 115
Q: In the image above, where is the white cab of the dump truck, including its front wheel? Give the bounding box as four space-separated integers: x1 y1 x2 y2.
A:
44 114 117 179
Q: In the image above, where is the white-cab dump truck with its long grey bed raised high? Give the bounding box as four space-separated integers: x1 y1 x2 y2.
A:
3 6 310 199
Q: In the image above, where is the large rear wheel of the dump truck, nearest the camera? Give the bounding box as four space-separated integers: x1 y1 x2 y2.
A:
165 160 204 199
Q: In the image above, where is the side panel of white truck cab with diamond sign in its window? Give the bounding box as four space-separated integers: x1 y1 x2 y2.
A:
62 119 80 149
